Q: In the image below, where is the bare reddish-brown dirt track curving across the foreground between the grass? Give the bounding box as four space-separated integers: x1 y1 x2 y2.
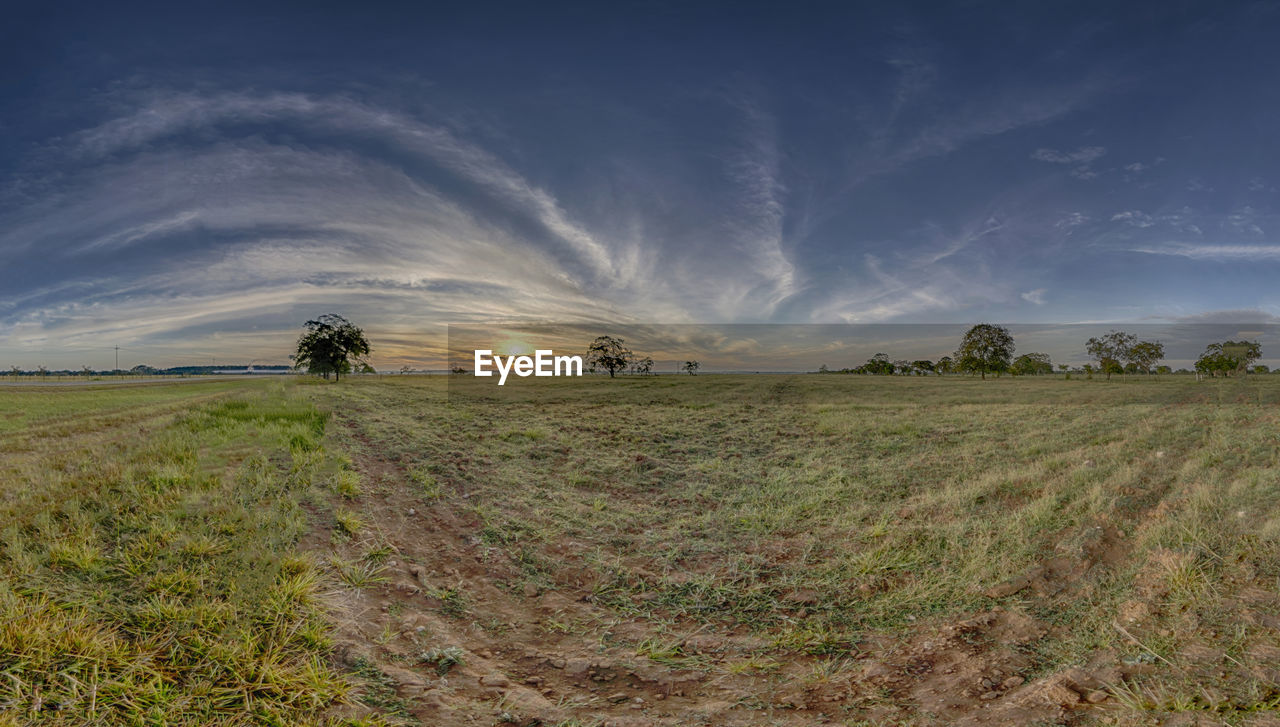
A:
303 415 1152 727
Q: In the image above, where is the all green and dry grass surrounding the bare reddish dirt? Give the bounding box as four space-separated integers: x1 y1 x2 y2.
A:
10 375 1280 724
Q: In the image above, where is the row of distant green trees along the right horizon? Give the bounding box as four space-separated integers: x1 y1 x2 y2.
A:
818 323 1270 380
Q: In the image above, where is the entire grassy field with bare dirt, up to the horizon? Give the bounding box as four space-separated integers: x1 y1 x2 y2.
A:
0 375 1280 726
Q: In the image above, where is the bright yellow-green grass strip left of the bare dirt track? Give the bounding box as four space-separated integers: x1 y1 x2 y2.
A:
0 383 384 724
